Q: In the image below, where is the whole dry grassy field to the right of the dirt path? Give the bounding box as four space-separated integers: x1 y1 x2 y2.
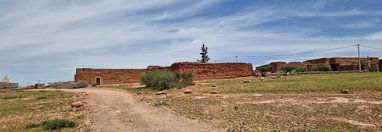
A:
120 73 382 131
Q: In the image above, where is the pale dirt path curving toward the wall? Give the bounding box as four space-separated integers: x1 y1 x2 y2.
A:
65 88 223 132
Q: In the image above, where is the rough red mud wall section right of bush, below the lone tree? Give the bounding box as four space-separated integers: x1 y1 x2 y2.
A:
170 62 253 81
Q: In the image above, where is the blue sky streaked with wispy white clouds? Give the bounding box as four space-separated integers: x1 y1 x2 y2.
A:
0 0 382 85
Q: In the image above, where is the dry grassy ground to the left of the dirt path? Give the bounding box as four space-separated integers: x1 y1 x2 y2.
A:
0 90 88 131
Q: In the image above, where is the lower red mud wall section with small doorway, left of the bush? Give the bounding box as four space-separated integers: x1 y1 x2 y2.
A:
75 68 146 85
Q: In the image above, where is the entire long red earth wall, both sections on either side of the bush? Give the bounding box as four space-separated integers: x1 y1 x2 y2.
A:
75 62 253 85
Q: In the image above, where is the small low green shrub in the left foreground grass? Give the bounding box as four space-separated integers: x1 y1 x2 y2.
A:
42 119 76 130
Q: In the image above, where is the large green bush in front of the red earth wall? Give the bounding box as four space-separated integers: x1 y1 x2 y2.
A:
141 70 193 90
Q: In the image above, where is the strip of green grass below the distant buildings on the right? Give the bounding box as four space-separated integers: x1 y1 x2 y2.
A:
190 72 382 93
